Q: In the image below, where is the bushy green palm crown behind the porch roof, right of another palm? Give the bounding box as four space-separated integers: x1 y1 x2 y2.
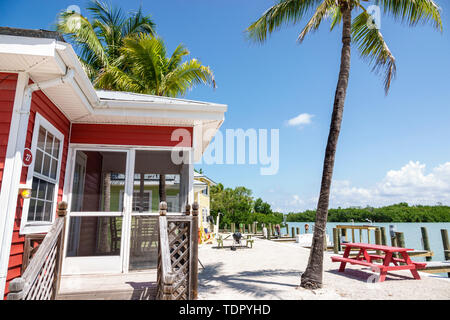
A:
97 34 215 97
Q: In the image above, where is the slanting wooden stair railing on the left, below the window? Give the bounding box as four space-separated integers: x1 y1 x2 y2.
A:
7 202 67 300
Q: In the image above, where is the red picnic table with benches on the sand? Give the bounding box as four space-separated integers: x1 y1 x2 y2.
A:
331 243 427 282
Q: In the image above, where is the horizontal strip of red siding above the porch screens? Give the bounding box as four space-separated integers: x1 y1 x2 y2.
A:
70 124 193 147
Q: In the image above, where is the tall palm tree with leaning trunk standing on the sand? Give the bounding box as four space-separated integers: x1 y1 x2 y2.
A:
246 0 442 289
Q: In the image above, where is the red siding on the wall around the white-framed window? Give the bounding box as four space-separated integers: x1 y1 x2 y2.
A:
5 91 70 296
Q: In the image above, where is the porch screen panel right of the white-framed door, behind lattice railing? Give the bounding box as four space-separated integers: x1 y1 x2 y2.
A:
126 150 188 271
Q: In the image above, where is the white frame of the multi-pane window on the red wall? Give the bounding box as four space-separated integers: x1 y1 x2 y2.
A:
20 112 64 234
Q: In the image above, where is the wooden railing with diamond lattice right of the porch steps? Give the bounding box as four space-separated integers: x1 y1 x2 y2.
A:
156 202 198 300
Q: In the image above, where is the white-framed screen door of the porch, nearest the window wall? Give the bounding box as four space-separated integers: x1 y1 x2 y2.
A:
63 150 128 274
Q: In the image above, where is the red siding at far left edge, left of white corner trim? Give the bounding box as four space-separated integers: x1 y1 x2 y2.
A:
0 73 17 190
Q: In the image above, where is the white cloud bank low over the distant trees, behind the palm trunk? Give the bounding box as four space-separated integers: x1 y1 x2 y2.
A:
266 161 450 212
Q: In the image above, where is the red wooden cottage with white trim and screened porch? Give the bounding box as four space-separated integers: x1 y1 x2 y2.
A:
0 28 227 296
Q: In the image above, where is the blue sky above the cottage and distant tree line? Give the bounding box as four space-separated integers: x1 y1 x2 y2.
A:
0 0 450 212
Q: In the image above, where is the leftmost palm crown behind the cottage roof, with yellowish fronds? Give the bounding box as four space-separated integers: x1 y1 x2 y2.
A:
56 0 155 81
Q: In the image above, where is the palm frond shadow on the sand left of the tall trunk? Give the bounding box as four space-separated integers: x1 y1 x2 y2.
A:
198 262 301 298
